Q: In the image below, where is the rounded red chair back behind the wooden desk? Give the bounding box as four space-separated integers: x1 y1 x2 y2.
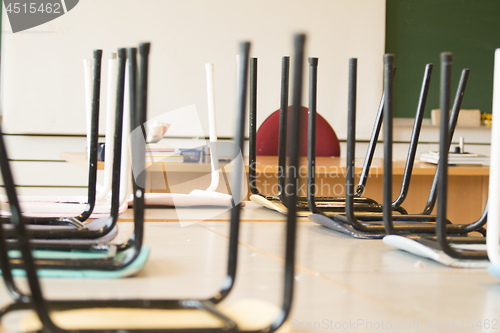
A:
256 106 340 156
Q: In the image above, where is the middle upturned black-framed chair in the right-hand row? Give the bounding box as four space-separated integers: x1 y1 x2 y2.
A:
309 55 486 238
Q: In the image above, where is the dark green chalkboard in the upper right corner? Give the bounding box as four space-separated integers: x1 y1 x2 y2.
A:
385 0 500 117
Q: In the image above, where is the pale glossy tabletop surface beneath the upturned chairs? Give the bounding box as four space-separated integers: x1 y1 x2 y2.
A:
0 203 500 332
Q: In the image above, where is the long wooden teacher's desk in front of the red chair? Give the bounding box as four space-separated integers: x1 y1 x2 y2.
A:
61 153 489 223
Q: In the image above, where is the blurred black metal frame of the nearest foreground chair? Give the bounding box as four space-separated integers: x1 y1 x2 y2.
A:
0 35 305 333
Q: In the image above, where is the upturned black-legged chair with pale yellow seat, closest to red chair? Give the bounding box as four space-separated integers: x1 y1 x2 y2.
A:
249 50 444 218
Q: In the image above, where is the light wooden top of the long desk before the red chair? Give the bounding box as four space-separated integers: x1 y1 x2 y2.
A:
60 152 490 176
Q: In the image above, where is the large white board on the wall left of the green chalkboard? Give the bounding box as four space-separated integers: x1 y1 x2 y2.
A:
1 0 385 139
